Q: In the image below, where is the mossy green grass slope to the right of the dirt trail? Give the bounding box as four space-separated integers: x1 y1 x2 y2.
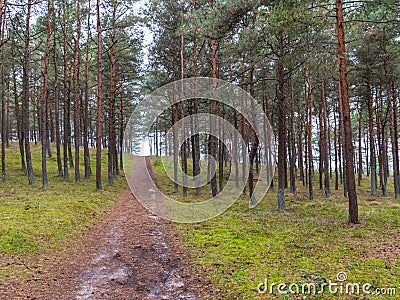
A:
152 159 400 299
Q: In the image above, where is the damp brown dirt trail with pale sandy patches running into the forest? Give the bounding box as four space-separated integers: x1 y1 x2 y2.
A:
75 191 200 300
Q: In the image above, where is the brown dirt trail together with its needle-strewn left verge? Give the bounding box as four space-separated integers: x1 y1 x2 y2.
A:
0 158 206 300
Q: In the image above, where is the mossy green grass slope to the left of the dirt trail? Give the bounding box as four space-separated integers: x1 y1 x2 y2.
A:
0 144 126 279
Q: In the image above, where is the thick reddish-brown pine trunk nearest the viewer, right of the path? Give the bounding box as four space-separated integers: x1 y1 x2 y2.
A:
336 0 359 224
